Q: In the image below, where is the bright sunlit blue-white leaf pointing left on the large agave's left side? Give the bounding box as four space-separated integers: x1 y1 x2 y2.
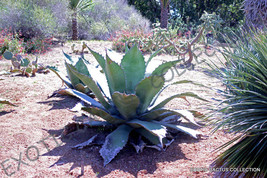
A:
64 88 105 109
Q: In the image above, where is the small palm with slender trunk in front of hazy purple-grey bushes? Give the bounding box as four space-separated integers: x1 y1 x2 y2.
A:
69 0 93 40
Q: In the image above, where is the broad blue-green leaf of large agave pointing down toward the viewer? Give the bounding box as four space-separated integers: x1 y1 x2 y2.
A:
99 125 133 166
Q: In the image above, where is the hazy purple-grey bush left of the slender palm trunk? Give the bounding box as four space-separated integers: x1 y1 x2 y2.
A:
0 0 68 39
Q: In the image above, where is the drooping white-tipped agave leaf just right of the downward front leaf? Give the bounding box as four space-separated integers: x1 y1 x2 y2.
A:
127 119 167 148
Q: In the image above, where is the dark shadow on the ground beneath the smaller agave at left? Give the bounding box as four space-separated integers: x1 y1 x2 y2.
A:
37 95 79 111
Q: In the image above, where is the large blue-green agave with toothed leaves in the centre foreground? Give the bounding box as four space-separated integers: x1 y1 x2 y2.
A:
62 45 205 165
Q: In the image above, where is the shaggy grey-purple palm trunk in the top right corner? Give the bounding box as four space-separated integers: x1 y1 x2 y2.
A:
243 0 267 28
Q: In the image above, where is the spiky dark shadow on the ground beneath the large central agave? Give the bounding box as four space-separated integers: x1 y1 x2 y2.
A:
43 123 202 177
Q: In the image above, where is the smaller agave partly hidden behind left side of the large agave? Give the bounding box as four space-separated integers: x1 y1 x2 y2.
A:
49 53 91 95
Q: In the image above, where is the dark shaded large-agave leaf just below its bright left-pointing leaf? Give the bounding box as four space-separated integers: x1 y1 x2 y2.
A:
82 107 125 124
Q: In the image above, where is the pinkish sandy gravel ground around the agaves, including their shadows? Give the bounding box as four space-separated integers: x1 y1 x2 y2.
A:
0 41 231 178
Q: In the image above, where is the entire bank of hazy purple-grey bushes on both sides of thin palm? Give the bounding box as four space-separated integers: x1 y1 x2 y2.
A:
0 0 150 40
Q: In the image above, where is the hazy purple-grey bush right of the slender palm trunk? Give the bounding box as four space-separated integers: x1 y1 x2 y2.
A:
79 0 150 40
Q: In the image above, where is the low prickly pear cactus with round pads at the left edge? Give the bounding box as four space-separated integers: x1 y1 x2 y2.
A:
3 51 49 77
